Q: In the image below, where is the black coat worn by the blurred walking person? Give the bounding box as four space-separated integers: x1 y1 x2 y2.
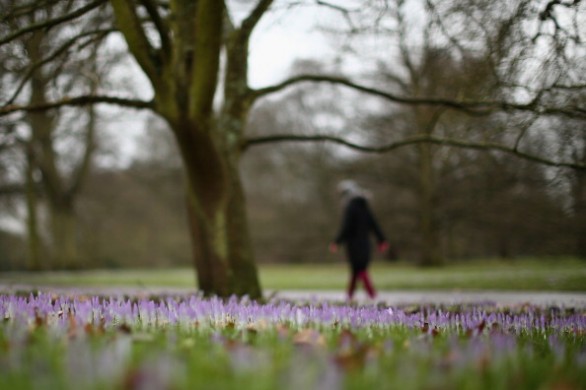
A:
334 197 386 272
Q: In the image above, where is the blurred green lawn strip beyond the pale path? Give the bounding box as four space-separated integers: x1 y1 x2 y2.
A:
0 258 586 291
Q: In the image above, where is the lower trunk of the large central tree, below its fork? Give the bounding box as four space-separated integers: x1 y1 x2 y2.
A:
175 126 261 298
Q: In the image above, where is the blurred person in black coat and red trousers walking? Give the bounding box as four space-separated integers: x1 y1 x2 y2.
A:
330 180 389 300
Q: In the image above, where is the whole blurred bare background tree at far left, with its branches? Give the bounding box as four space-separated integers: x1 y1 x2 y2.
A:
3 1 111 269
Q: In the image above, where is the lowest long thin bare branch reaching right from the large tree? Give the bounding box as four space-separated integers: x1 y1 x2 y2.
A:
242 134 586 170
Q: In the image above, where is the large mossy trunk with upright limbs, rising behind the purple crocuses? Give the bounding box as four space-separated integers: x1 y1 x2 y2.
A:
111 0 264 298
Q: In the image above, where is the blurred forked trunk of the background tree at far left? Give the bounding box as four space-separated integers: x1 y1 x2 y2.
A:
26 22 97 268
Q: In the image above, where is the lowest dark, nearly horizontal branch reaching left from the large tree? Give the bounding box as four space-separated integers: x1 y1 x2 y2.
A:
0 95 154 117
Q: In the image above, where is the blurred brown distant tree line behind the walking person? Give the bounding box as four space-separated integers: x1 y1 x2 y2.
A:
2 92 586 269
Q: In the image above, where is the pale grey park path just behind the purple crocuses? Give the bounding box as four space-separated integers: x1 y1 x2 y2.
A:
0 283 586 309
